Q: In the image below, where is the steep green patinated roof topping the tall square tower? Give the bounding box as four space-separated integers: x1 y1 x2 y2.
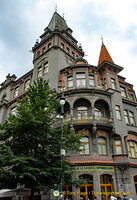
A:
48 12 68 31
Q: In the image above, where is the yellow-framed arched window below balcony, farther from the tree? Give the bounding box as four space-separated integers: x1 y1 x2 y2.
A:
98 137 107 155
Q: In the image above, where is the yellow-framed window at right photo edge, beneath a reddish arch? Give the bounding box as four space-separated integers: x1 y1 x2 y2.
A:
127 141 137 158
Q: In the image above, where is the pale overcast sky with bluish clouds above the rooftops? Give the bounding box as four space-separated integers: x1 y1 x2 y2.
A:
0 0 137 92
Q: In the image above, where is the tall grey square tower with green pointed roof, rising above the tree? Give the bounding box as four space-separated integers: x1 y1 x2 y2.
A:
32 12 84 90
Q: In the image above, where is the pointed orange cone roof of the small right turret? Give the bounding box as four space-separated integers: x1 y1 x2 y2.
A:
98 41 114 66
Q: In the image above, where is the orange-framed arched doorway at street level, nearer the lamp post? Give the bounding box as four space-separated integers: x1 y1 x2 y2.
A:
79 174 94 200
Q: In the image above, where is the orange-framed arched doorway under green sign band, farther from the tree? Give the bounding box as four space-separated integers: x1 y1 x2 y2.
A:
100 174 113 200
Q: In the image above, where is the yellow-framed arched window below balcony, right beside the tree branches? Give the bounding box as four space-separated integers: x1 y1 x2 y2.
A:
80 137 89 155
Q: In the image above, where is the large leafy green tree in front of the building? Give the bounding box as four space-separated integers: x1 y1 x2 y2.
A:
0 79 81 198
